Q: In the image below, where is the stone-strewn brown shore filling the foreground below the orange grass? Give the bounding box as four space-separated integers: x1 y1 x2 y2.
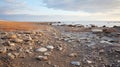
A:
0 21 120 67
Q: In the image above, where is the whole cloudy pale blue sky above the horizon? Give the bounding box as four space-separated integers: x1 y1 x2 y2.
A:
0 0 120 21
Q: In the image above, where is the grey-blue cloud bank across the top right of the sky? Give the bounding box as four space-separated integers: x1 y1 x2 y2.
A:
43 0 120 12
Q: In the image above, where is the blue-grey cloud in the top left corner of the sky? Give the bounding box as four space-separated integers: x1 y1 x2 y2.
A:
0 0 25 14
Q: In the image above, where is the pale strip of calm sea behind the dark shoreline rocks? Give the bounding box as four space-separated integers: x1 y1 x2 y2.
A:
55 21 120 27
